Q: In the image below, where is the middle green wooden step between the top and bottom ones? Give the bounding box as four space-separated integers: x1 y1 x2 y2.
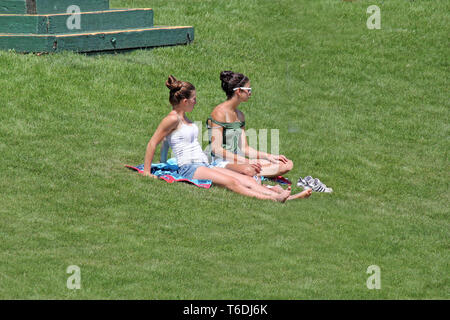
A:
0 9 153 34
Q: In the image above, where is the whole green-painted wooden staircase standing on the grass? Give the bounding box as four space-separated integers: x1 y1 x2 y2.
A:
0 0 194 53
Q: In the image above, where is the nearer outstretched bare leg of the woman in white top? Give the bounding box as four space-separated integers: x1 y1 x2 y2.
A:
193 167 290 202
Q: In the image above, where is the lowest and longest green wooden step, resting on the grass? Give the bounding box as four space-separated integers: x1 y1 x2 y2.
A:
0 26 194 53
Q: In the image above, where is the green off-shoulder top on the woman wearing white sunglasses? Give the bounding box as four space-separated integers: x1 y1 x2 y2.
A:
206 117 245 157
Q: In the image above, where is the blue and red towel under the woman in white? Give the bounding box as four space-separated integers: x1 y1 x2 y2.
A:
125 158 212 189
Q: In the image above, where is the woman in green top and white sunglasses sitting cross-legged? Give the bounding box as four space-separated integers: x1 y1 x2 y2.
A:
206 71 293 177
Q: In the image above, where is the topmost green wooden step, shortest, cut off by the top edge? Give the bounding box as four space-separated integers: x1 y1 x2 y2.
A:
0 0 109 14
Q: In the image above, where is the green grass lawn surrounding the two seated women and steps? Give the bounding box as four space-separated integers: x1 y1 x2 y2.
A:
0 0 450 299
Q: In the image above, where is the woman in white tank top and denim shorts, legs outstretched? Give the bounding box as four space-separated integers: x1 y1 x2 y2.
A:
143 76 311 202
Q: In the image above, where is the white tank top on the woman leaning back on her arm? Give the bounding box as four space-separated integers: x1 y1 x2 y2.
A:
166 122 209 167
